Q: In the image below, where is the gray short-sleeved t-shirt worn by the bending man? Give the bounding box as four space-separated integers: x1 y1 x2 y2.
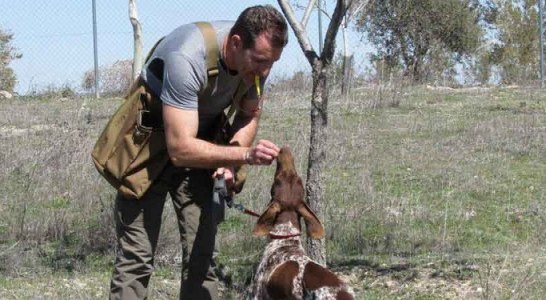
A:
141 21 263 137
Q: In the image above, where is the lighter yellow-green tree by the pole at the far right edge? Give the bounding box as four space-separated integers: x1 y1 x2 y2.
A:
483 0 539 84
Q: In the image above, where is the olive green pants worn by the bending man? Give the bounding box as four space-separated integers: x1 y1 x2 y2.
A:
110 165 218 300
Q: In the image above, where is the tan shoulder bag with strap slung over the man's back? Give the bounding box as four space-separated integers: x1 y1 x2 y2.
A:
91 22 242 199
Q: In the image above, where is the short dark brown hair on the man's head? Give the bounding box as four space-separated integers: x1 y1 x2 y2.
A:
229 5 288 49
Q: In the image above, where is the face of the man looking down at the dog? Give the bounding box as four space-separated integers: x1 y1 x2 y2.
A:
237 32 283 85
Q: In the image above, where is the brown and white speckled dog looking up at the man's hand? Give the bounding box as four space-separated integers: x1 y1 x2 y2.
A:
252 147 354 300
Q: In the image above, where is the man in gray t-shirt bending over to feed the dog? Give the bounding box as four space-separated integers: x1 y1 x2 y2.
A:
110 5 288 300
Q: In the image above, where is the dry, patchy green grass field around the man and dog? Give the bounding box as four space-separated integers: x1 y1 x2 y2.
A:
0 84 546 299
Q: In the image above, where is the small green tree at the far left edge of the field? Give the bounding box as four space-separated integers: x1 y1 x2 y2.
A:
0 28 23 93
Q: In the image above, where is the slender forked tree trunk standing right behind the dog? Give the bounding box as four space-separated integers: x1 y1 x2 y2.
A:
278 0 352 264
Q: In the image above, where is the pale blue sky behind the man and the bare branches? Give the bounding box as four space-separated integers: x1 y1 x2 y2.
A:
0 0 368 94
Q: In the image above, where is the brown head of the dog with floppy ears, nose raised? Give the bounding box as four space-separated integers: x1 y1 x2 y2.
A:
254 146 324 239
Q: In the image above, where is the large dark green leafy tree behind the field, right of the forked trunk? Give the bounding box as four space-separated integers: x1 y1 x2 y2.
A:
357 0 482 82
